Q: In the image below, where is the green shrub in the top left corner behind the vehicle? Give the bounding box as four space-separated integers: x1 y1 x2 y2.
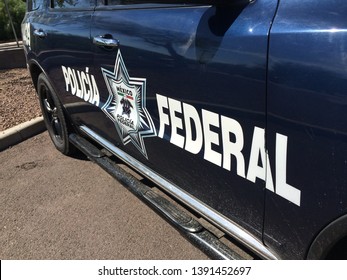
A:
0 0 26 41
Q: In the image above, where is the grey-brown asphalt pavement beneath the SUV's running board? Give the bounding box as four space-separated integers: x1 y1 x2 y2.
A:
0 132 207 260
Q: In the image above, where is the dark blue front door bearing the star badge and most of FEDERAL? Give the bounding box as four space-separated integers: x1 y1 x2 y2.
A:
87 0 277 256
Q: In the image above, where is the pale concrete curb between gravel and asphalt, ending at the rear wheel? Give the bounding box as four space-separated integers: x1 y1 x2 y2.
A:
0 117 46 151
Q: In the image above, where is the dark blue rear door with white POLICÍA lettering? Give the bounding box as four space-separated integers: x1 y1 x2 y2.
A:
27 0 95 111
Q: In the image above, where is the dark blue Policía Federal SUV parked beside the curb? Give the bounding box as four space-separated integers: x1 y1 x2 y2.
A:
22 0 347 259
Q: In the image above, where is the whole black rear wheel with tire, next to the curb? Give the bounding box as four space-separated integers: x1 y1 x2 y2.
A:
37 73 75 155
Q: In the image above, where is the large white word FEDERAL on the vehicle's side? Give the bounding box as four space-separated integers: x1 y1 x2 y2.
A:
158 94 301 206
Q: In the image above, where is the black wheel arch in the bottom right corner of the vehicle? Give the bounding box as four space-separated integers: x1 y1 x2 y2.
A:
307 214 347 260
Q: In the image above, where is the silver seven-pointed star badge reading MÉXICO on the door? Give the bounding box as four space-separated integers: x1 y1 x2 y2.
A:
101 50 156 159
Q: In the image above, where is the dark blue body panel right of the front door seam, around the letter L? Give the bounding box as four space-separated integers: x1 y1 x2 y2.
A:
264 1 347 258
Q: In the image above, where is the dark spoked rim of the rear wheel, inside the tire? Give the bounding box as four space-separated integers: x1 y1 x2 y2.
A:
42 86 63 143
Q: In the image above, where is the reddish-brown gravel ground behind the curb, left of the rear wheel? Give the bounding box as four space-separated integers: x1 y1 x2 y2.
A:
0 68 41 131
